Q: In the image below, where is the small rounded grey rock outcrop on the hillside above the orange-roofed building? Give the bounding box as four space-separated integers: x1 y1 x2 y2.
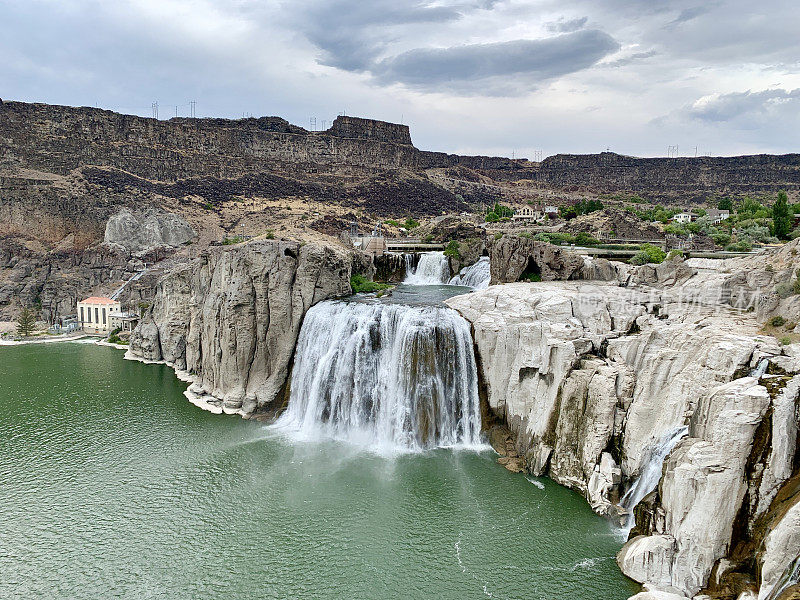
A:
103 208 197 254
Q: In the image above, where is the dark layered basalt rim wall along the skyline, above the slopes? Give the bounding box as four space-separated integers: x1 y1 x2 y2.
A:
0 101 800 201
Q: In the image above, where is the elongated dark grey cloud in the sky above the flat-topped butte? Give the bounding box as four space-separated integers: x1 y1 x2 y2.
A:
374 29 619 88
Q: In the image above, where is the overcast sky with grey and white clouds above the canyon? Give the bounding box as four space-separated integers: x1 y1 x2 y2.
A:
0 0 800 158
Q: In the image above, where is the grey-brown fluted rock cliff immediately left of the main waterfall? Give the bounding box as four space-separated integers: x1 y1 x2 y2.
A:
129 241 364 415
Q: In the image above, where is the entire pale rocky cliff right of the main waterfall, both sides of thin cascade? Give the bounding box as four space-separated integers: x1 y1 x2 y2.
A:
448 244 800 600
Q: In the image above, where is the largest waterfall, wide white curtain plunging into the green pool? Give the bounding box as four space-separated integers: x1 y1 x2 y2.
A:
276 300 481 452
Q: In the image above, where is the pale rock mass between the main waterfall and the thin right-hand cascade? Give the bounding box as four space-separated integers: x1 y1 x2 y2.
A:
448 282 780 514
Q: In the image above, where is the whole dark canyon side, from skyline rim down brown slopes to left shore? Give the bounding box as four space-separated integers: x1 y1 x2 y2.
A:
0 100 800 321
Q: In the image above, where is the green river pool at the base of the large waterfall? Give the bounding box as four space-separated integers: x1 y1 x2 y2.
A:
0 343 637 600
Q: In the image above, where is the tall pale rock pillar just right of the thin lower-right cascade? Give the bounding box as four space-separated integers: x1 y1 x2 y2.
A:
618 377 770 597
